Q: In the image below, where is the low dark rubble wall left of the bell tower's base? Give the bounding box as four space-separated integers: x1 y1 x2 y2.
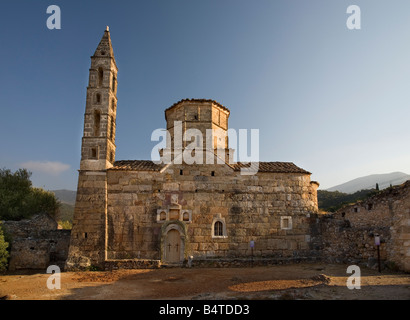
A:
3 214 70 270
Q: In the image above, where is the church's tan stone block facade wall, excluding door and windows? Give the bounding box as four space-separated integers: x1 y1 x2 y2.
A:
107 165 317 259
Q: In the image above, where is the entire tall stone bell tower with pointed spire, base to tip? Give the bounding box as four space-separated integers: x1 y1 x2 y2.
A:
66 27 118 270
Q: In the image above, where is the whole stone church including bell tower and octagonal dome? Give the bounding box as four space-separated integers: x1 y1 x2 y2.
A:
66 27 319 270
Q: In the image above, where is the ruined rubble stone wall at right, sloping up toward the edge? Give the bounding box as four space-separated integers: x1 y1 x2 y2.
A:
318 181 410 271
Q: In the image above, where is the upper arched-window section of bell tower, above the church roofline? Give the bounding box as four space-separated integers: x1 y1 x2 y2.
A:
80 27 118 170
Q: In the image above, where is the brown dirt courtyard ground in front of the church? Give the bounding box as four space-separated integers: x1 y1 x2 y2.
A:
0 264 410 300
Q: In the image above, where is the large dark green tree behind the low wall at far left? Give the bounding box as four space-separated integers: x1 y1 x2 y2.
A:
0 169 60 220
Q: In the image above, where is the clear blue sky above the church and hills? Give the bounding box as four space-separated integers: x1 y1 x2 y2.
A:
0 0 410 190
